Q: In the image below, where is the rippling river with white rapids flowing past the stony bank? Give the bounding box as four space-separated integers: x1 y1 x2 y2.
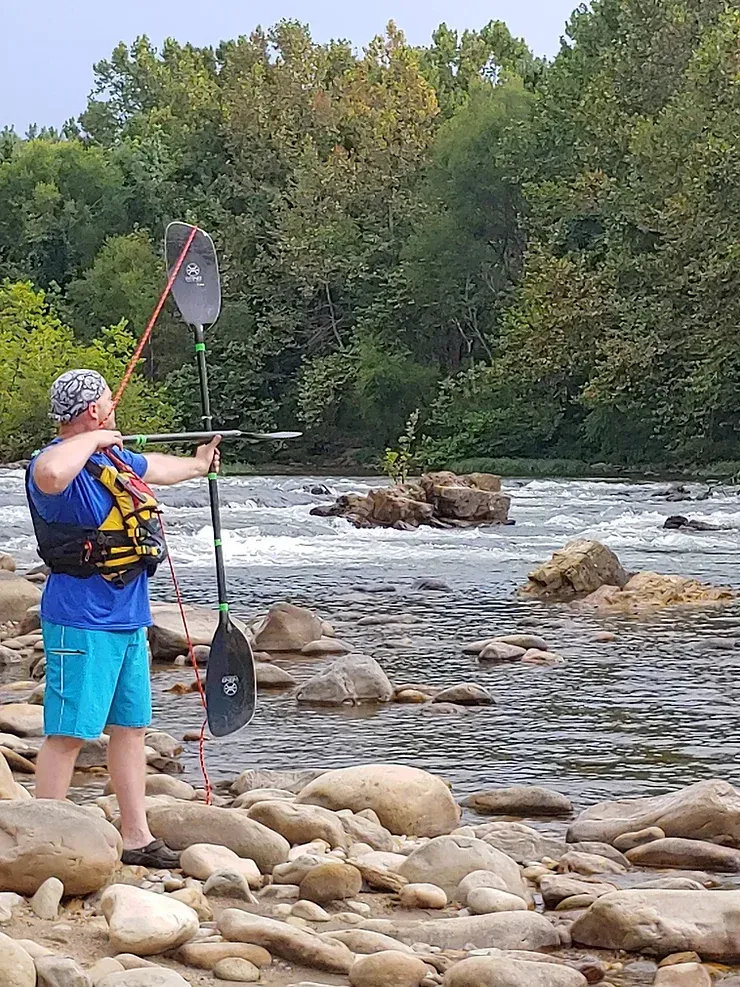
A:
0 470 740 820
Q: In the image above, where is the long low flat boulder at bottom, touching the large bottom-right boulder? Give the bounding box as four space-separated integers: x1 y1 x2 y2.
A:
361 912 560 951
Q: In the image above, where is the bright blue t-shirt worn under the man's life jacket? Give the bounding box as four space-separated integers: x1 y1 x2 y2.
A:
28 439 152 631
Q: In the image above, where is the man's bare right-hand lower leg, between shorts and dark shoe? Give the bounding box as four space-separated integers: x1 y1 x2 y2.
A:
108 726 154 850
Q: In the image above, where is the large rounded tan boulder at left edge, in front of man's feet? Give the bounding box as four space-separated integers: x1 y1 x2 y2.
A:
0 800 121 895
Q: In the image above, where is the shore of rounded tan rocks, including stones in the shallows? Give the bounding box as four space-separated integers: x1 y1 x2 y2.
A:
0 542 740 987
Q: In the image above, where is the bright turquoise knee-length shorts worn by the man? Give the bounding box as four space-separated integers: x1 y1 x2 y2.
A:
41 620 152 740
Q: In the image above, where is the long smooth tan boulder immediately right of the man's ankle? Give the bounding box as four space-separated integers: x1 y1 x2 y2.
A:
147 802 290 874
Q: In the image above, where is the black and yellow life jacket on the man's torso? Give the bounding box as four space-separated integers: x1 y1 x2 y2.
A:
26 450 167 588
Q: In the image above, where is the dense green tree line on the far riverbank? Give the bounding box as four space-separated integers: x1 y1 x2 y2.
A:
0 0 740 465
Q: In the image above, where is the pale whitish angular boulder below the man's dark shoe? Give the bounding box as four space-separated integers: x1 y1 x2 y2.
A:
101 884 198 956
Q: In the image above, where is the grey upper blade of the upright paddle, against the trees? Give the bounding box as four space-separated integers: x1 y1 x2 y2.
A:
164 223 221 326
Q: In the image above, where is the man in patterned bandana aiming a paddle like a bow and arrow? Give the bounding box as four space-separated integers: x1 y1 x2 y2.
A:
27 370 220 869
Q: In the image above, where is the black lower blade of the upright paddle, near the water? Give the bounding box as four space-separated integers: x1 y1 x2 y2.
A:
206 614 257 737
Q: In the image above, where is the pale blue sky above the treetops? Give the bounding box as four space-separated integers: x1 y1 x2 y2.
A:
0 0 578 133
